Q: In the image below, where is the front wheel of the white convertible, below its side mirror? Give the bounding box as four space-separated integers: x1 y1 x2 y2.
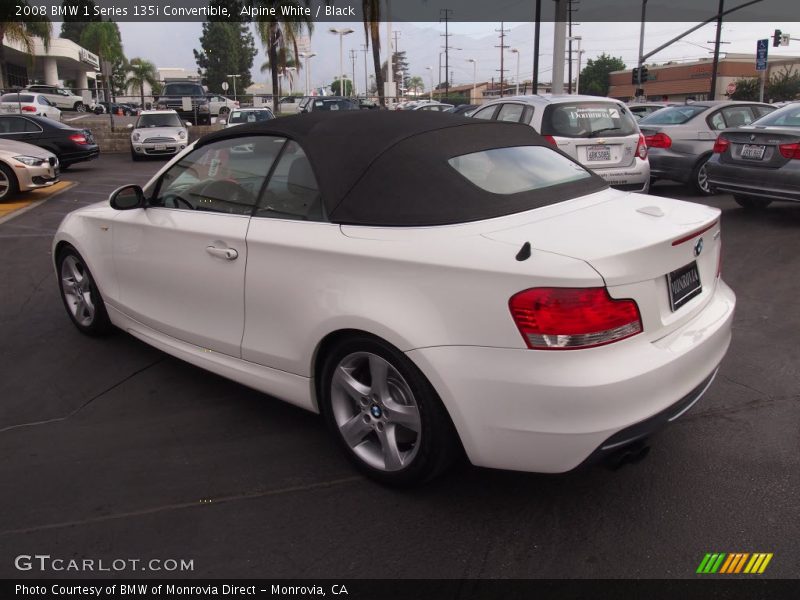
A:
56 246 113 336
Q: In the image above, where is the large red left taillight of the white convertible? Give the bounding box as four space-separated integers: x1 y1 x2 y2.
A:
508 288 642 350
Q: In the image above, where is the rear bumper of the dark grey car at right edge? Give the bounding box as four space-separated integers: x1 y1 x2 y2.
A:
706 158 800 202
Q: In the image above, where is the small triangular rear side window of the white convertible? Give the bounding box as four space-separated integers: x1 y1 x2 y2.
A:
255 141 325 221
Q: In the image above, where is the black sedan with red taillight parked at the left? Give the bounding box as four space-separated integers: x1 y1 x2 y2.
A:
0 115 100 169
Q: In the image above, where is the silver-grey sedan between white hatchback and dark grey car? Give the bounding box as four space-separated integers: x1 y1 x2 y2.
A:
639 100 775 196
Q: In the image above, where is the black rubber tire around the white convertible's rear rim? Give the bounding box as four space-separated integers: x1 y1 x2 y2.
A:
318 334 460 487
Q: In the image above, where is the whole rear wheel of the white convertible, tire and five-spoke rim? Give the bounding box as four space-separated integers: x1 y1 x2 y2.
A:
320 336 459 486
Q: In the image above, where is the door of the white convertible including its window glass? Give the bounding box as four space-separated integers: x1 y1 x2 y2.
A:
111 136 285 357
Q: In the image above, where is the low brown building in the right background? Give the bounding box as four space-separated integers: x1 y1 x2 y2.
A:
608 54 800 102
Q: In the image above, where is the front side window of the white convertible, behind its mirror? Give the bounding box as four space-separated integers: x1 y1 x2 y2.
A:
150 136 286 215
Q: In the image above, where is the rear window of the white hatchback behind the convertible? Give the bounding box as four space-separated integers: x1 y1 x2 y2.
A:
542 101 639 138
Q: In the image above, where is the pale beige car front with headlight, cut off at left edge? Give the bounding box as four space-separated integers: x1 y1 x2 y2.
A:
0 139 59 202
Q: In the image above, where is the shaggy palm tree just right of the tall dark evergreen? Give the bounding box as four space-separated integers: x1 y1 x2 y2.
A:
256 0 314 112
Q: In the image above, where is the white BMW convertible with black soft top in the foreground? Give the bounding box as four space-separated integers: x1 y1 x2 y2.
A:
53 111 735 485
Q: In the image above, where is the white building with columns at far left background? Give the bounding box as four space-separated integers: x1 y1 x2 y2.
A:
3 38 100 90
